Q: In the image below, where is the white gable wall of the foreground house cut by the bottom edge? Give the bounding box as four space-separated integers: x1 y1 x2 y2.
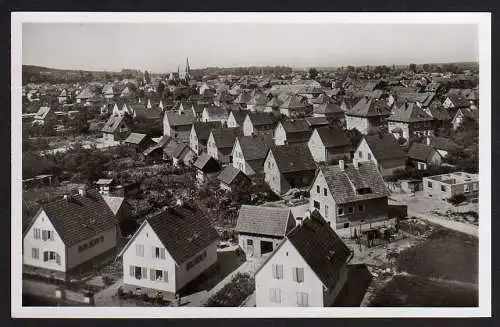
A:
255 240 324 307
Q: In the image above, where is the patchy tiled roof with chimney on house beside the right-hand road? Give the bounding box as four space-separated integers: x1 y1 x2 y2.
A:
319 161 389 204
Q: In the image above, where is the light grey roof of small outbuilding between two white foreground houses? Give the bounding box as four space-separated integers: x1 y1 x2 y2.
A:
235 205 295 237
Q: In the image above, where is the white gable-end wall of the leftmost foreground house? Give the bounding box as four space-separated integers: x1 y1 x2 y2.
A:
23 210 67 272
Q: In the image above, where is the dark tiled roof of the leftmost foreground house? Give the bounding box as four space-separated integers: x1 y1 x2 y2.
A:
27 190 118 246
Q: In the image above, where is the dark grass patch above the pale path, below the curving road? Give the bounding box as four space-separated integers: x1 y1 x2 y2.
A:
396 229 478 284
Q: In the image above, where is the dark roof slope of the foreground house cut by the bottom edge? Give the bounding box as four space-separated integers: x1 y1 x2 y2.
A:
286 215 351 289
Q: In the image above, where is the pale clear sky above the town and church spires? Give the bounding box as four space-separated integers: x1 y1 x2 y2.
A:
22 23 479 73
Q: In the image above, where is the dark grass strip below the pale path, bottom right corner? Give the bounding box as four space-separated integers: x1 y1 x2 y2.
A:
370 275 478 307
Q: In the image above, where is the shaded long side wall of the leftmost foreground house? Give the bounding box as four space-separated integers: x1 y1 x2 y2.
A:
66 227 118 270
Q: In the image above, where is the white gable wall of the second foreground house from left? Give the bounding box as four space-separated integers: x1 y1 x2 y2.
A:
122 223 178 293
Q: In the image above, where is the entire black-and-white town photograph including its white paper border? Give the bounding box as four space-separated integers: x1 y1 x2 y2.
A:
11 12 491 318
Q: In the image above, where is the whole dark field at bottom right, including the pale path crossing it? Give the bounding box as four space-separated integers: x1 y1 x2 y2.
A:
369 228 478 307
